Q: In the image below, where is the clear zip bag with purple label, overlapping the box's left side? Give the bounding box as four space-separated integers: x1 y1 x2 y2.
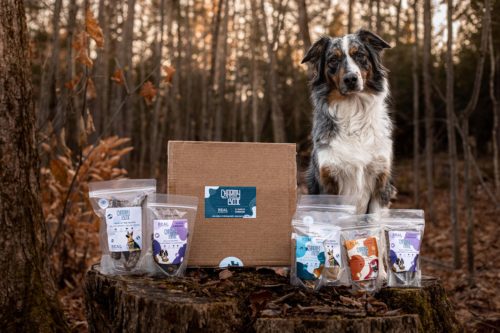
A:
141 194 198 276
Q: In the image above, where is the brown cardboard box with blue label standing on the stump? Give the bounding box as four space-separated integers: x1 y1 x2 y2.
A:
167 141 297 267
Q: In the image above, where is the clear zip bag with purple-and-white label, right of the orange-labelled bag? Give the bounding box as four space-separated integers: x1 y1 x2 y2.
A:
381 209 425 287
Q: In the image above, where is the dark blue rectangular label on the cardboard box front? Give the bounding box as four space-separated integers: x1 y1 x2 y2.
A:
205 186 257 219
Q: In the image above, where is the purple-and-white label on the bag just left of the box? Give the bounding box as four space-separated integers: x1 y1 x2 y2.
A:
153 219 188 265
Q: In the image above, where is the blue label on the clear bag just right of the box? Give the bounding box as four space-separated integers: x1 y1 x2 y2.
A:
295 236 325 280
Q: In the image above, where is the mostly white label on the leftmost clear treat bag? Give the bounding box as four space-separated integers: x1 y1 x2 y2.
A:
105 207 142 252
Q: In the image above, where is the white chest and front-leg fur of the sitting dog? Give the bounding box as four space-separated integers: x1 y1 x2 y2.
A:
316 93 392 211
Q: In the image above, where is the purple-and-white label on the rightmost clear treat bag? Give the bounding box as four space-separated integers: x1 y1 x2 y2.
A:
389 230 421 273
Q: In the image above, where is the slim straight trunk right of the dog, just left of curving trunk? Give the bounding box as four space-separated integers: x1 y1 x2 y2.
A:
446 0 462 269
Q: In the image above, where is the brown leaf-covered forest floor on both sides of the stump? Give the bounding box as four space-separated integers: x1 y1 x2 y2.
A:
59 159 500 332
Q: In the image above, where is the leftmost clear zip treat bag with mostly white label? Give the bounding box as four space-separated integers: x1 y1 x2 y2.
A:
89 179 156 274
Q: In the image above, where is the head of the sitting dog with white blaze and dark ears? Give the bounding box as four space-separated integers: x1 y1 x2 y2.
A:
302 30 391 96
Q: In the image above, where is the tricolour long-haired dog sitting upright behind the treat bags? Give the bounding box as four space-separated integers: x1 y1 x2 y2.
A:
302 29 396 214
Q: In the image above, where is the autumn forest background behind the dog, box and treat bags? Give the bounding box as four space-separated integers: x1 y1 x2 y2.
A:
16 0 500 331
